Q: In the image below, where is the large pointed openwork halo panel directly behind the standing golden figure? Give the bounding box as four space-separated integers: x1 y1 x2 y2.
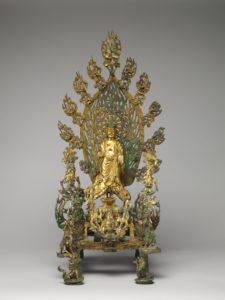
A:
81 79 144 185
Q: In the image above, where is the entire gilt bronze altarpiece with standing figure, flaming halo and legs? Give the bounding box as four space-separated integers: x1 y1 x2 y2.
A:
55 32 164 284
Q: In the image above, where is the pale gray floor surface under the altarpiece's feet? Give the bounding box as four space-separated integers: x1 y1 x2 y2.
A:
0 250 225 300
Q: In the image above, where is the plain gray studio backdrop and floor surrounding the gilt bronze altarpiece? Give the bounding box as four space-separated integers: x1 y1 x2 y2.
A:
0 0 225 299
